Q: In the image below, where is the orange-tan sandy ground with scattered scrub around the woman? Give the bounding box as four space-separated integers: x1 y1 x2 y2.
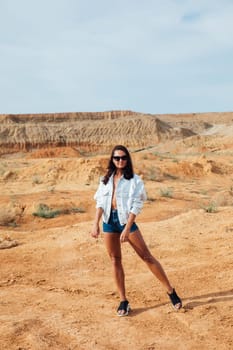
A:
0 131 233 350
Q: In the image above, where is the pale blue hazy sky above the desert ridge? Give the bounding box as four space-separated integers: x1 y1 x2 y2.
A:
0 0 233 114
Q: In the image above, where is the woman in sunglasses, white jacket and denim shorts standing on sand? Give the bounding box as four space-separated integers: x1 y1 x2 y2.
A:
91 145 182 316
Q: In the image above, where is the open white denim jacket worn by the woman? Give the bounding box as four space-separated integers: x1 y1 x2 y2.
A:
94 174 147 225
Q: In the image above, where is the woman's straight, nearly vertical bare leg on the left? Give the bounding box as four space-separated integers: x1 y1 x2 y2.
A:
104 233 126 301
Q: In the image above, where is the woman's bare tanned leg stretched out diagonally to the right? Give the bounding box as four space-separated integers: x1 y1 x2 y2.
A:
129 230 173 294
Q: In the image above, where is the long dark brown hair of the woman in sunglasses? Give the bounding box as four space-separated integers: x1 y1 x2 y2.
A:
103 145 134 185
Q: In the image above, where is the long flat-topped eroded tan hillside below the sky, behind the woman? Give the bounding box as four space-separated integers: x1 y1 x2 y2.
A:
0 111 197 154
